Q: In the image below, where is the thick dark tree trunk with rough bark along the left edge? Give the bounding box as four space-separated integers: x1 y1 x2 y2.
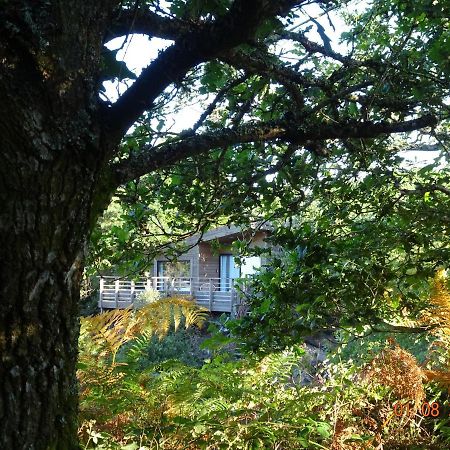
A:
0 0 114 450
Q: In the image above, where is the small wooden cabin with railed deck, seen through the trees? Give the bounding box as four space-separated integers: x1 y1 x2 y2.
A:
99 226 270 314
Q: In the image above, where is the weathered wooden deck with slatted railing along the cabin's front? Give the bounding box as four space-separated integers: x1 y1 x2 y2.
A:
98 277 243 315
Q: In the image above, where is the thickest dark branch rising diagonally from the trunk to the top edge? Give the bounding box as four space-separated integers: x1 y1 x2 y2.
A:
105 0 304 142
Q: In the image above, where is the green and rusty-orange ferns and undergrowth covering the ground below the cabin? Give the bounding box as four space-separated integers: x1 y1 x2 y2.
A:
79 272 450 450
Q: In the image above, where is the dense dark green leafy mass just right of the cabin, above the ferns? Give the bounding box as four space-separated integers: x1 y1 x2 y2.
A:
234 149 450 348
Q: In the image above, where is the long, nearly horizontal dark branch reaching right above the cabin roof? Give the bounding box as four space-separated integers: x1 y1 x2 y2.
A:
112 116 437 186
